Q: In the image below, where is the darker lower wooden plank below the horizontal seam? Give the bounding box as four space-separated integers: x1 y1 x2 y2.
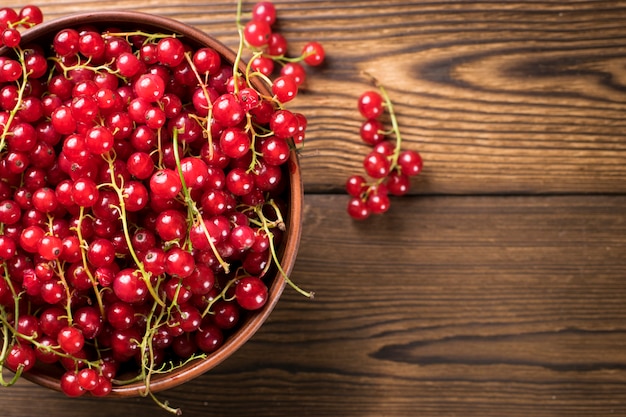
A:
0 195 626 417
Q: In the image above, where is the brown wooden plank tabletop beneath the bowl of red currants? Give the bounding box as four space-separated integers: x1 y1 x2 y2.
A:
0 0 626 417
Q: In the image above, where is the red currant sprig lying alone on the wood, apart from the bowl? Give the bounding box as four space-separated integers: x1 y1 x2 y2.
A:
346 76 423 220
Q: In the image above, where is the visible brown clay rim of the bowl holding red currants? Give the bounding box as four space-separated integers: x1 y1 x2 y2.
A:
5 11 303 396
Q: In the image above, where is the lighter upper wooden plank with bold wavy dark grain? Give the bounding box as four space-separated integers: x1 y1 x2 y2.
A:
11 0 626 194
